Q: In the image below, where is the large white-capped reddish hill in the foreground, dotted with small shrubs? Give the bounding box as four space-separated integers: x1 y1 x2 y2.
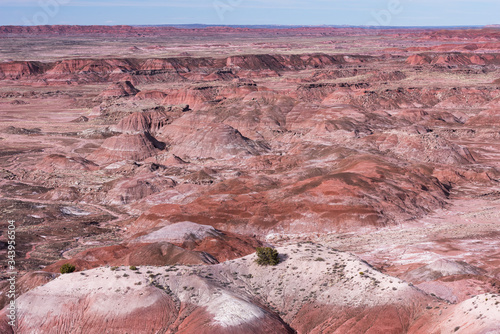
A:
3 244 431 333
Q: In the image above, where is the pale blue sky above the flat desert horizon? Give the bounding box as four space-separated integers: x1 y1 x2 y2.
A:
0 0 500 26
